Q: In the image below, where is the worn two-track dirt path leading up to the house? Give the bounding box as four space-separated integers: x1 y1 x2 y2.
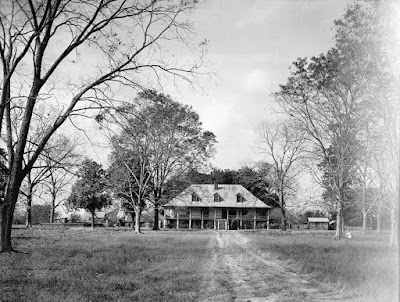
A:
202 231 350 302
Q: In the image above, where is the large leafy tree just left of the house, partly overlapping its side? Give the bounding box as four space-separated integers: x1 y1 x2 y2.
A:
103 90 216 230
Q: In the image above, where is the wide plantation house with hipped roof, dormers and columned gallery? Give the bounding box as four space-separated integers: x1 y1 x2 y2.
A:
163 184 271 230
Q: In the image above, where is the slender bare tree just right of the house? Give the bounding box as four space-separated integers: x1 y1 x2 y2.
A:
257 120 306 231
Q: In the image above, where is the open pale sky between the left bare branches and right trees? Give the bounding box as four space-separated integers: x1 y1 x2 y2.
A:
162 0 350 169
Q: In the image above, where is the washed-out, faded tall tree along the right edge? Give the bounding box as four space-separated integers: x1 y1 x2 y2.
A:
335 1 400 245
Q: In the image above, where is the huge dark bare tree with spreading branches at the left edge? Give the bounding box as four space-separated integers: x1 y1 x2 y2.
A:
0 0 204 252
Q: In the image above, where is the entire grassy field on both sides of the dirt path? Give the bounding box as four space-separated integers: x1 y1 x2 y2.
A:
0 228 398 301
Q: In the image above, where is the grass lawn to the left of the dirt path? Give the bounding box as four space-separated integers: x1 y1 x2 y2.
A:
0 229 212 302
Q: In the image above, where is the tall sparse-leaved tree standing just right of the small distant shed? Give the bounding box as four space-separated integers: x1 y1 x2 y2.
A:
275 49 360 239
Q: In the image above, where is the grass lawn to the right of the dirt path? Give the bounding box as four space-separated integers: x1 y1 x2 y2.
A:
248 231 399 302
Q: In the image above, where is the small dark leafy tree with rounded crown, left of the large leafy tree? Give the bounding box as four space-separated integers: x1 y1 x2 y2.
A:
66 159 109 228
